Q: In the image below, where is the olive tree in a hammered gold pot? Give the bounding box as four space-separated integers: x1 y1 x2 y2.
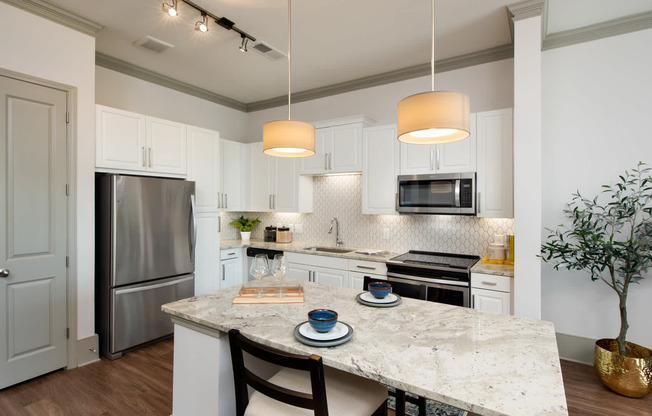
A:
541 162 652 397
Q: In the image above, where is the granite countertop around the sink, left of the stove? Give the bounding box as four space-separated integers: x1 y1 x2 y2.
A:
220 239 400 263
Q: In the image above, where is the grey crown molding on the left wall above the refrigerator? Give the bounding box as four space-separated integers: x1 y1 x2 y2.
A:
95 52 247 112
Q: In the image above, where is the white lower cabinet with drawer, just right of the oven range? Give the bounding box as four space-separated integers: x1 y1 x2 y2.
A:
471 273 514 315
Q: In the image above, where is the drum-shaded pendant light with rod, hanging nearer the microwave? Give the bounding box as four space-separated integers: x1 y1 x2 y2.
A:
397 0 470 144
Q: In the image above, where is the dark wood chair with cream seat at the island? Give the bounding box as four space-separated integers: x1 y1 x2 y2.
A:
229 329 387 416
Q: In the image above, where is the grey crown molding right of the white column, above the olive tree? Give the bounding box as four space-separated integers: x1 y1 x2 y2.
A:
541 12 652 50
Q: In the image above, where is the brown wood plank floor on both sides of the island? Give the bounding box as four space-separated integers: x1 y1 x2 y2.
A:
0 339 652 416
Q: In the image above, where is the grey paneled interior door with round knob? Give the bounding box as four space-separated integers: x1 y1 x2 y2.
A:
0 76 67 389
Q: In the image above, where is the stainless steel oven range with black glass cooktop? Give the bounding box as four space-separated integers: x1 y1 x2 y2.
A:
387 250 480 308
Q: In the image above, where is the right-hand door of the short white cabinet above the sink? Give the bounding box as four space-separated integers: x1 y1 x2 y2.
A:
326 124 362 173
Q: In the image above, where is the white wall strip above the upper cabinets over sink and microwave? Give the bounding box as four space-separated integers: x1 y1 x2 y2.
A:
244 59 514 142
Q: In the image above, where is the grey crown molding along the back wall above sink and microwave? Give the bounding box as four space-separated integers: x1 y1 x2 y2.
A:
247 44 514 112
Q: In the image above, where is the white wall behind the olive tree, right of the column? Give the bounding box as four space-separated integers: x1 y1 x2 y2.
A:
542 30 652 348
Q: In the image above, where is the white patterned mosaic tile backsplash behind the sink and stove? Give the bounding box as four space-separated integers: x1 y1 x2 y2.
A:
221 175 514 256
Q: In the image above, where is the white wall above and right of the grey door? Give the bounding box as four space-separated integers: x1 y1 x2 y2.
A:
0 3 95 339
